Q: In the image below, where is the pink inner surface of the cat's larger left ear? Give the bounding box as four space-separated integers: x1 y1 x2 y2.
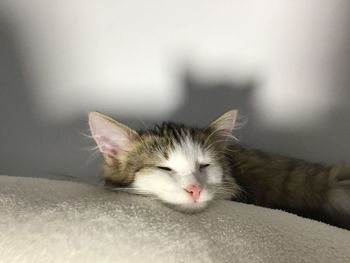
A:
90 115 131 156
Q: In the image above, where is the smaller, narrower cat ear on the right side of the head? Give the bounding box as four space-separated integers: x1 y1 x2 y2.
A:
207 110 237 141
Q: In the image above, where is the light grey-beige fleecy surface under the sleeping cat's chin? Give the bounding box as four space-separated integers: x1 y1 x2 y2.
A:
0 176 350 263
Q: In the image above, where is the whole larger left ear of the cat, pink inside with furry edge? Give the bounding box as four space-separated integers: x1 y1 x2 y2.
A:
89 112 138 163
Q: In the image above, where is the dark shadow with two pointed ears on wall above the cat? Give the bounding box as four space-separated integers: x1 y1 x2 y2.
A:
169 69 256 126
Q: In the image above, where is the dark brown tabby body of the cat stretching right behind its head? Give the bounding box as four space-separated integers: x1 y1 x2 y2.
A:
228 145 350 229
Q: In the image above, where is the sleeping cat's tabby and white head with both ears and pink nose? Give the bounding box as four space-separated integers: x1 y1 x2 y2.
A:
89 110 238 212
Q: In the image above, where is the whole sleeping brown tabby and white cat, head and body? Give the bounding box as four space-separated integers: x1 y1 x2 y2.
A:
89 110 350 229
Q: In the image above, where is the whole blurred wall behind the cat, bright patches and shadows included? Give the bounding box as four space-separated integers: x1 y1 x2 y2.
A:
0 0 350 178
